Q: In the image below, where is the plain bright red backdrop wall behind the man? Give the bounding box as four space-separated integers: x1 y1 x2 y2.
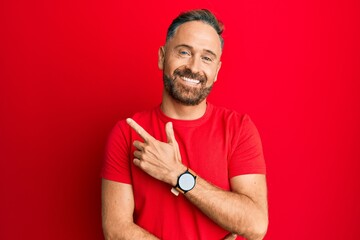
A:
0 0 360 239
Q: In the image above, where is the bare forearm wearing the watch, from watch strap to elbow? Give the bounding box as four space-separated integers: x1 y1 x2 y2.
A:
185 177 268 240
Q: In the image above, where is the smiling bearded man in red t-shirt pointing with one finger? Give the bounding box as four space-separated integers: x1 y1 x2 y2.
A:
102 10 268 240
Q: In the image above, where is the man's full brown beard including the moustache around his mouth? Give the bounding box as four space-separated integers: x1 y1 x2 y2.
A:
163 68 213 106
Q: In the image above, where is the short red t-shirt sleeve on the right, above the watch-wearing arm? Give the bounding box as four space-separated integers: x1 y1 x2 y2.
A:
229 115 266 178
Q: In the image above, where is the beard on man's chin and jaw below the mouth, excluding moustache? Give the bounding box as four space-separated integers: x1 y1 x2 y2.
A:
163 74 213 106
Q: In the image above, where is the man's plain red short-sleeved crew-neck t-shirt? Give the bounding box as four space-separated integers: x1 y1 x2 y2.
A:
102 103 266 240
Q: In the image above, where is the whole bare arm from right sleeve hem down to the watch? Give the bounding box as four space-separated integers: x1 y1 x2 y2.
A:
185 174 268 240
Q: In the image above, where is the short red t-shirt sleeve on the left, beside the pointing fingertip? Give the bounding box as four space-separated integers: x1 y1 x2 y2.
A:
101 121 131 184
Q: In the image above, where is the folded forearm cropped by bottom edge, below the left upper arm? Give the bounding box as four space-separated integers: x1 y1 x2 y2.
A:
104 223 158 240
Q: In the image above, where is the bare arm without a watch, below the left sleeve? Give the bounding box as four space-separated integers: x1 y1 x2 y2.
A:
102 179 158 240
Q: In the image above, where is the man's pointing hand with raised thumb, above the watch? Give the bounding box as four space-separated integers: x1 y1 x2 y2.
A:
126 118 186 186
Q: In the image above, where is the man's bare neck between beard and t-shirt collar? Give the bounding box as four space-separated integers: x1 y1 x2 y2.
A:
161 90 206 120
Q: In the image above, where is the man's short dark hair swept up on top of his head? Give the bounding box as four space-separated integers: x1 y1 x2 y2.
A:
166 9 224 48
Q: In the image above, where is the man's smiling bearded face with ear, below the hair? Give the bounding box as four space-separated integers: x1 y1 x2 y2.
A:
158 21 222 106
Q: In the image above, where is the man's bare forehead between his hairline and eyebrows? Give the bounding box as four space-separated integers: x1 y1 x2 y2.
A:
168 21 221 55
